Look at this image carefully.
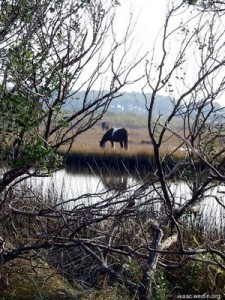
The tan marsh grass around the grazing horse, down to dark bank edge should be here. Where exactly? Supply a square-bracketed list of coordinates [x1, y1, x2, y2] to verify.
[61, 123, 193, 178]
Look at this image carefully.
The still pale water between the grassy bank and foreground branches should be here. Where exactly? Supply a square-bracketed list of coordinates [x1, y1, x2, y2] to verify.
[25, 170, 225, 237]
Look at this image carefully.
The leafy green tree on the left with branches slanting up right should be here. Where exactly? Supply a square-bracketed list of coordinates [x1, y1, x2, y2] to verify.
[0, 0, 142, 265]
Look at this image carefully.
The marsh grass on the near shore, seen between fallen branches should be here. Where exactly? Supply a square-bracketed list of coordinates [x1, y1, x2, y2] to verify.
[0, 190, 225, 300]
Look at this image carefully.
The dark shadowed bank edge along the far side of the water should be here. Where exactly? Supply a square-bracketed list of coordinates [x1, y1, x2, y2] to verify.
[65, 149, 207, 177]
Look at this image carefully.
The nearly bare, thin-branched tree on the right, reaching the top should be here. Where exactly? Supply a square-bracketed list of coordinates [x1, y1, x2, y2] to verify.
[140, 1, 225, 299]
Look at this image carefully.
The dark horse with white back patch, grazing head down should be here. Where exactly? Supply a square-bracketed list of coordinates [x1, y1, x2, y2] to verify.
[100, 128, 128, 149]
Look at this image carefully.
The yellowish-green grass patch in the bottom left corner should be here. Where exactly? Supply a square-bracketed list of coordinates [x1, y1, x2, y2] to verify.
[0, 254, 84, 300]
